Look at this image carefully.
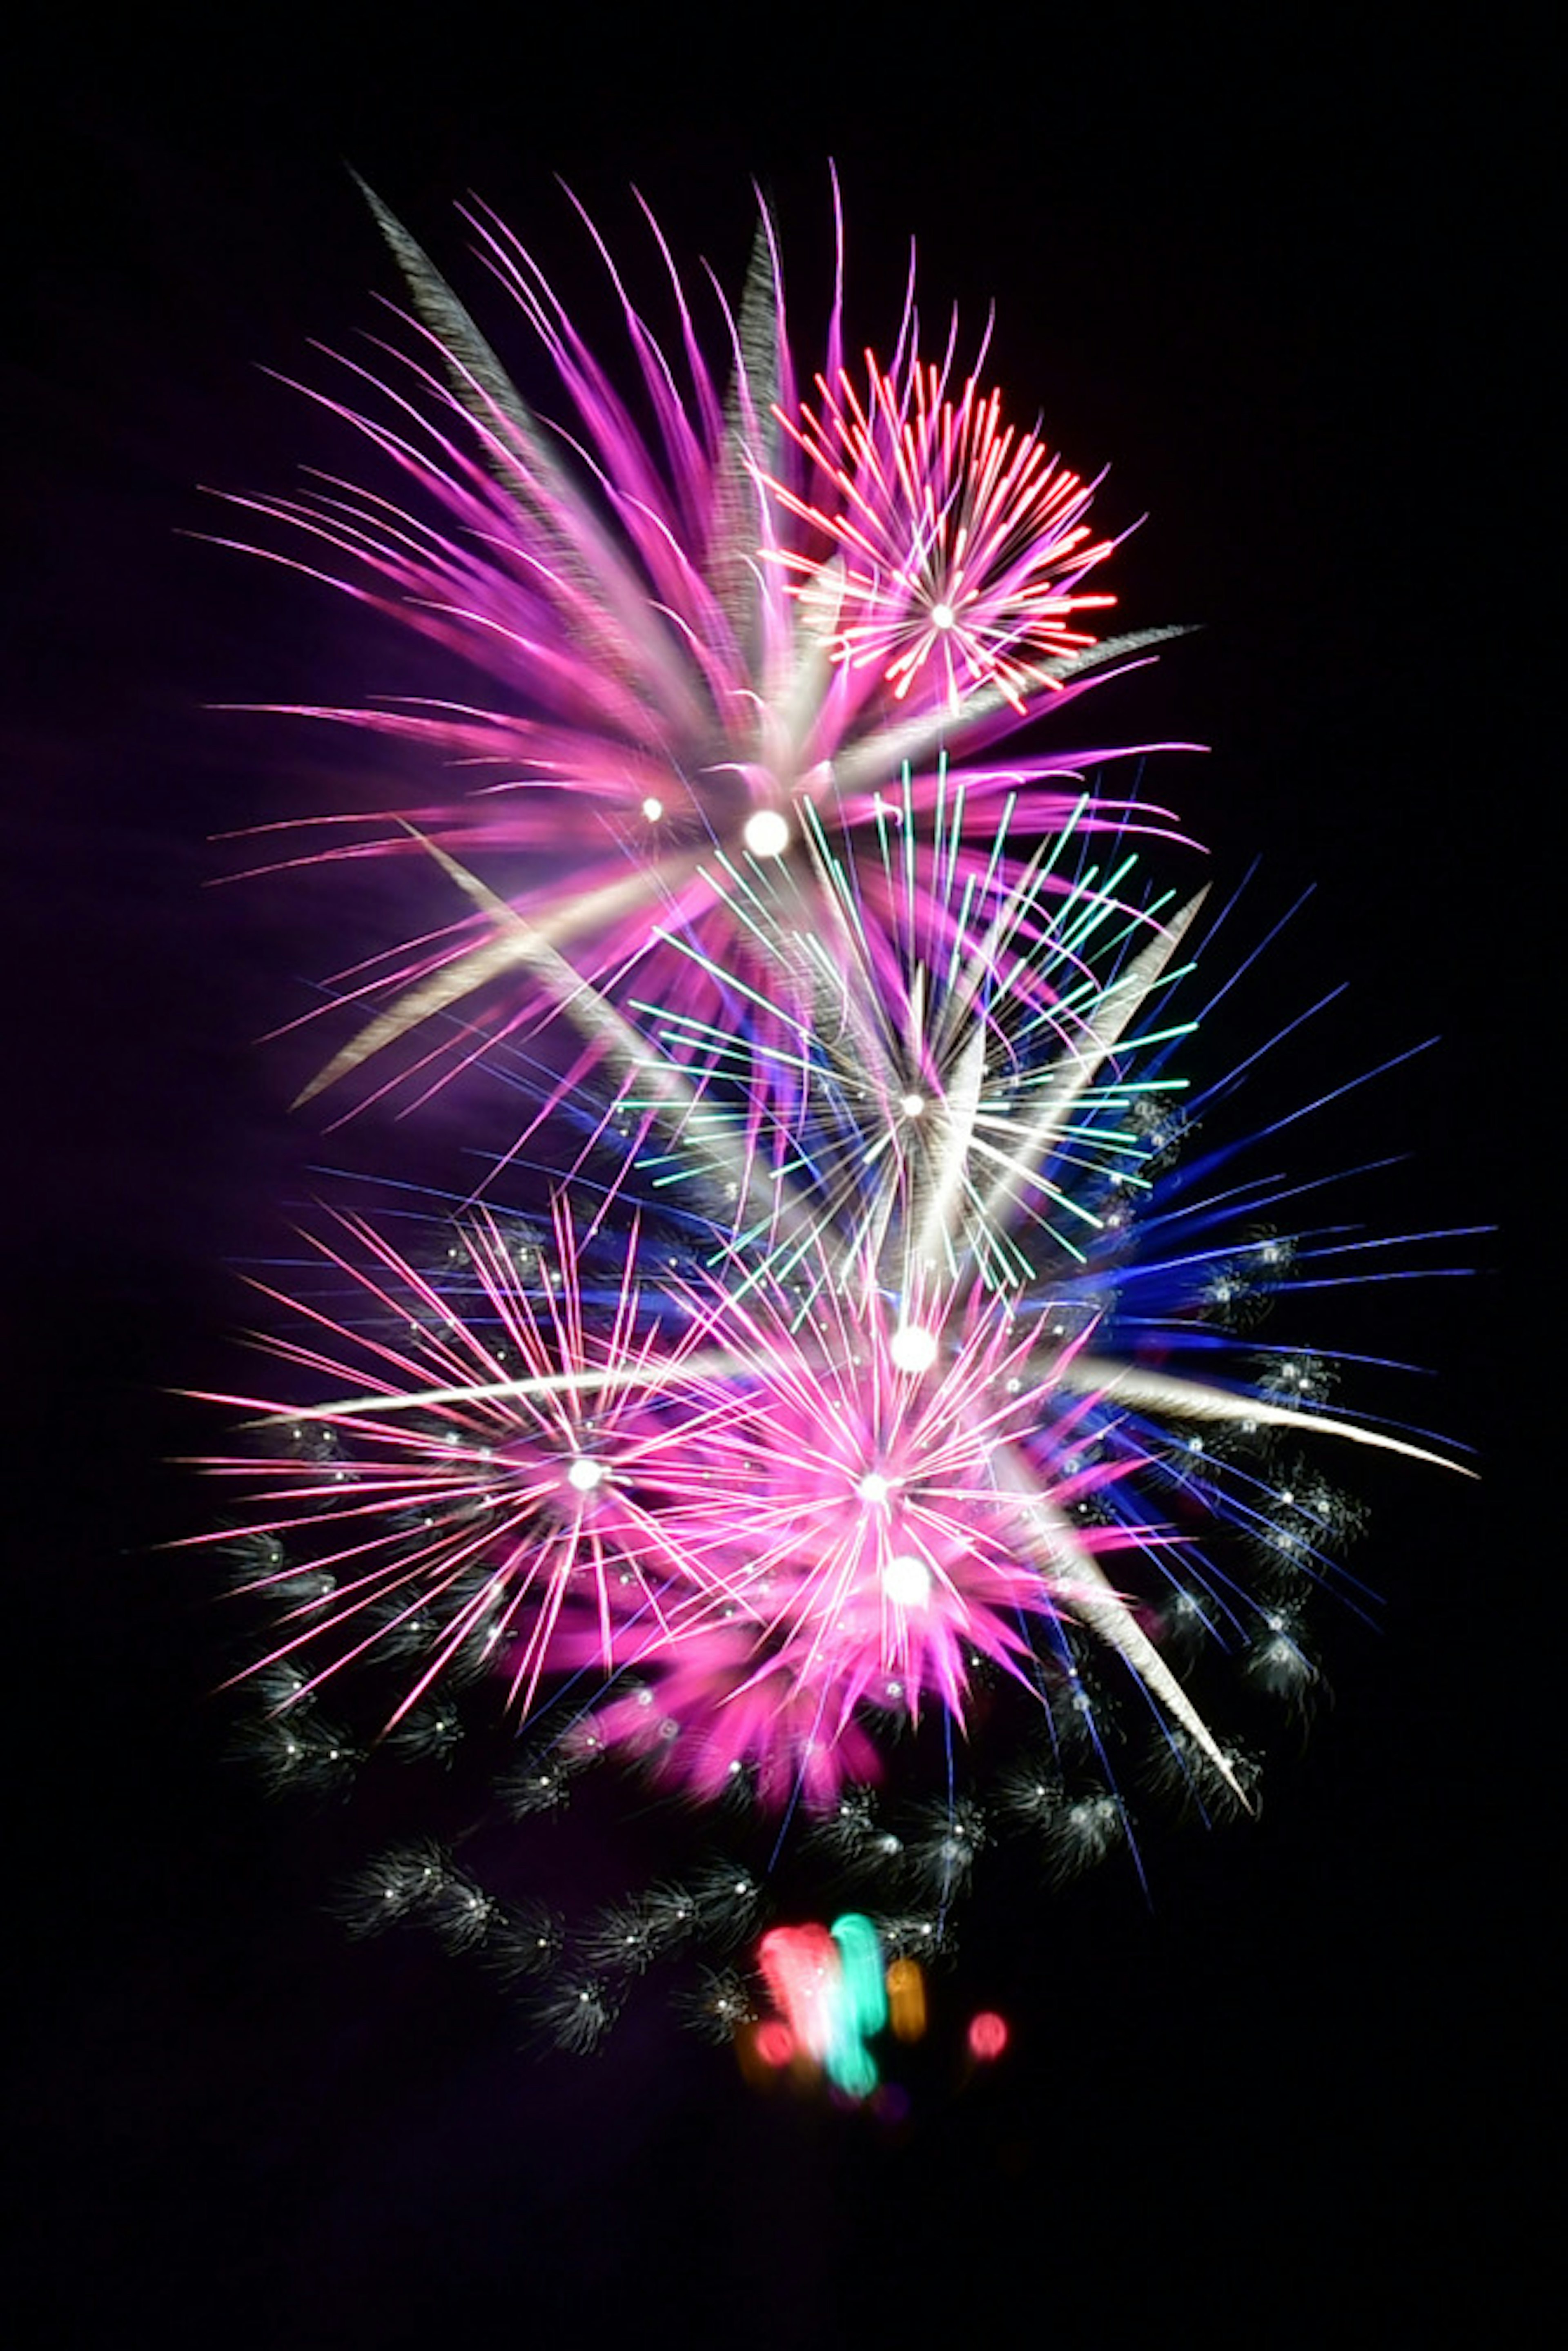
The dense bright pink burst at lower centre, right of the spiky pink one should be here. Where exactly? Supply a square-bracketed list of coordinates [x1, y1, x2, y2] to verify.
[555, 1265, 1133, 1810]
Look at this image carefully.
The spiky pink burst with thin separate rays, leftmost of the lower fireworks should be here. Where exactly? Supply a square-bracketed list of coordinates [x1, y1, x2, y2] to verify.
[190, 1201, 743, 1721]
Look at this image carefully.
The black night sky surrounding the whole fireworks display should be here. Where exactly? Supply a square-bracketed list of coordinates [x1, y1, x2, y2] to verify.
[5, 9, 1547, 2346]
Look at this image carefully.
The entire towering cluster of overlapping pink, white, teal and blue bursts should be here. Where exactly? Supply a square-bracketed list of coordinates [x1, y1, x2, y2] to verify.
[193, 183, 1453, 2048]
